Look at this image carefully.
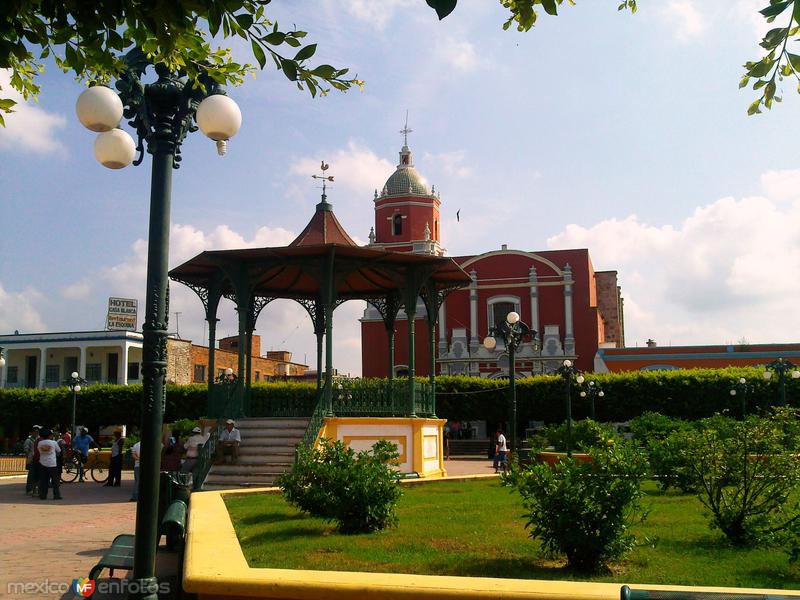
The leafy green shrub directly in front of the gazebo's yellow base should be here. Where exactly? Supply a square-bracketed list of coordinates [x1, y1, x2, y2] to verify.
[276, 439, 402, 533]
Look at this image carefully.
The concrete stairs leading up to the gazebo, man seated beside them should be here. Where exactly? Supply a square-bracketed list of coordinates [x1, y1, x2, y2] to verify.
[203, 418, 308, 490]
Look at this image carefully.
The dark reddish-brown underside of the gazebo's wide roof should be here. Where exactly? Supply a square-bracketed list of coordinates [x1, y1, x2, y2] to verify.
[169, 244, 470, 300]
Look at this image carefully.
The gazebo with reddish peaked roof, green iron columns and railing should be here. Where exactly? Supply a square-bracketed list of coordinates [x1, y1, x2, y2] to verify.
[169, 189, 470, 476]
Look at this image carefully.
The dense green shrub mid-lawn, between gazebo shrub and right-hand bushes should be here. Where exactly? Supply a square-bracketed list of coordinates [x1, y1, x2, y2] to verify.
[506, 444, 647, 573]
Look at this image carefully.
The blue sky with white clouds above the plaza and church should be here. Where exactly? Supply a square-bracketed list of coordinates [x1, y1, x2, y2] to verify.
[0, 0, 800, 375]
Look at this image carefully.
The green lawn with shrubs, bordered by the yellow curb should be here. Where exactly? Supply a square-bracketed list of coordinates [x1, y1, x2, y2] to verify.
[226, 480, 800, 589]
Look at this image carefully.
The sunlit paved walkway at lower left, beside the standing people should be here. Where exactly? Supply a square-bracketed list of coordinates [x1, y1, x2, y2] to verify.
[0, 472, 136, 600]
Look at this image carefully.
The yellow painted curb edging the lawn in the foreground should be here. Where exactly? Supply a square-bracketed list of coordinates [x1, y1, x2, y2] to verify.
[183, 488, 800, 600]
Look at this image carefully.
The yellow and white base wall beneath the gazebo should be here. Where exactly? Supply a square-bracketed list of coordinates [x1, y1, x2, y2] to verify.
[317, 417, 447, 478]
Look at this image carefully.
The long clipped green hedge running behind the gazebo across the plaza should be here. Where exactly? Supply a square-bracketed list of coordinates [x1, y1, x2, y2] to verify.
[0, 367, 800, 446]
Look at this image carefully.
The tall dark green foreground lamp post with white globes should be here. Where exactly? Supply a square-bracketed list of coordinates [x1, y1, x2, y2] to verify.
[76, 49, 242, 600]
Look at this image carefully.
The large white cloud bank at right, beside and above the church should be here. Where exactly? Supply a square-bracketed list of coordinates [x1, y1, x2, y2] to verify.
[547, 180, 800, 345]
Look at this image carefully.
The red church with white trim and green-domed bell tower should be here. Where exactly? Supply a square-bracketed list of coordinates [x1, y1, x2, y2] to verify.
[361, 138, 625, 377]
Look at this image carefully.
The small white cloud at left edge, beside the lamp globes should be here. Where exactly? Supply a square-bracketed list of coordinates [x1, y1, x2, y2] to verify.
[0, 69, 66, 155]
